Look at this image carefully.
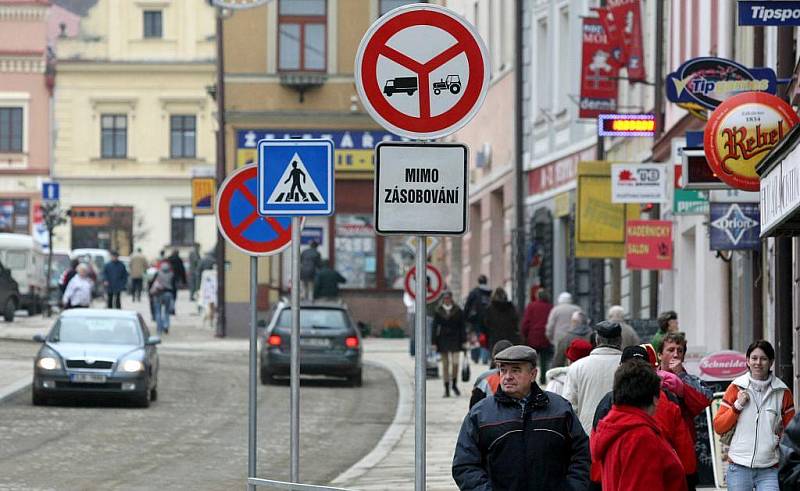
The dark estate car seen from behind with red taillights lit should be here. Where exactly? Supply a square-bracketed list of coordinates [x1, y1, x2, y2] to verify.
[260, 302, 362, 387]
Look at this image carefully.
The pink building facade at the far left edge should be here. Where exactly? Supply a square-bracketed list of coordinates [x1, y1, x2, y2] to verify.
[0, 0, 53, 245]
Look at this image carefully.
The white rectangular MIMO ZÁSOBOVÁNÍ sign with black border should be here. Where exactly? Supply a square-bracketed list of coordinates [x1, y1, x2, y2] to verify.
[375, 142, 469, 235]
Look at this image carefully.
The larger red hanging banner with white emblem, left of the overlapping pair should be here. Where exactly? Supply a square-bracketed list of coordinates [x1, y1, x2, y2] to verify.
[578, 17, 619, 118]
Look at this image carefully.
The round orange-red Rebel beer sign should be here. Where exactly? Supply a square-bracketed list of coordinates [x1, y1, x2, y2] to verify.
[703, 92, 800, 191]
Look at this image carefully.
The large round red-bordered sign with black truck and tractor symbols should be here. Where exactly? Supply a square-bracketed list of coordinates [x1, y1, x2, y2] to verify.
[355, 4, 490, 139]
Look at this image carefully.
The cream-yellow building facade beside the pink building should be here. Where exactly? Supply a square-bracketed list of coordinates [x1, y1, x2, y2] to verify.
[52, 0, 216, 258]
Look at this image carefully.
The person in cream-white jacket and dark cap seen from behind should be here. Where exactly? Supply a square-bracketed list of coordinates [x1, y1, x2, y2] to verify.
[564, 321, 622, 434]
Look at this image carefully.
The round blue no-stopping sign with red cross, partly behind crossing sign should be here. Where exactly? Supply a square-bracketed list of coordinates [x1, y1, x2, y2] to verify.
[216, 165, 292, 256]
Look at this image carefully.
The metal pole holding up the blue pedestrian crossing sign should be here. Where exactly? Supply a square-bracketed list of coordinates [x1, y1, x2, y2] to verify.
[289, 217, 300, 482]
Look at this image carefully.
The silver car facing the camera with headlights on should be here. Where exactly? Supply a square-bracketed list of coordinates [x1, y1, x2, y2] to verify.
[33, 309, 161, 407]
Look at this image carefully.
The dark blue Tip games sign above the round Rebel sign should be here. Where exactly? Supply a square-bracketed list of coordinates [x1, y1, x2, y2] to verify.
[666, 57, 778, 120]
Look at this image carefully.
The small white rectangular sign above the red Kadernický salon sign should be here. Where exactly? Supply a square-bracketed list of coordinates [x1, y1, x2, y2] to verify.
[611, 164, 669, 203]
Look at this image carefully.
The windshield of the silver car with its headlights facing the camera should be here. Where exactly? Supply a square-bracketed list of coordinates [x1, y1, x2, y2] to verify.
[50, 317, 141, 345]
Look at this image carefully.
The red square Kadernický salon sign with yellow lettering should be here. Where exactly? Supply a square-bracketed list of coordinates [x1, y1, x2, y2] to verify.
[625, 220, 672, 269]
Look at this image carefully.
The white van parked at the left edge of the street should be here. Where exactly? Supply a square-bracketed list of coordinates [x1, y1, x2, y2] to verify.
[0, 233, 47, 315]
